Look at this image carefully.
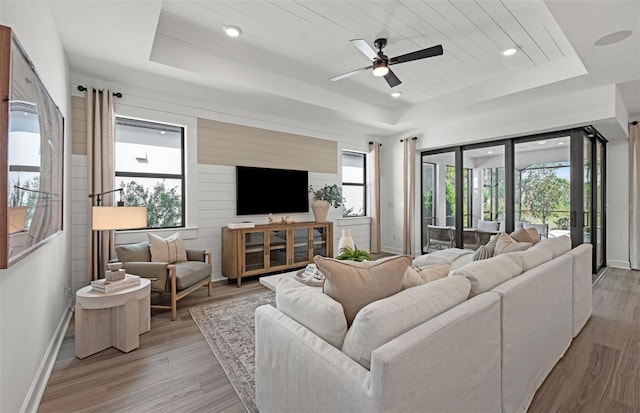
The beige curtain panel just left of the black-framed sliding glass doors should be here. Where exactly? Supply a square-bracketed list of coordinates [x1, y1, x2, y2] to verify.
[402, 138, 417, 255]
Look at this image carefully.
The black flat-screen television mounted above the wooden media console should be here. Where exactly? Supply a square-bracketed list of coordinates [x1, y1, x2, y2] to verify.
[236, 166, 309, 215]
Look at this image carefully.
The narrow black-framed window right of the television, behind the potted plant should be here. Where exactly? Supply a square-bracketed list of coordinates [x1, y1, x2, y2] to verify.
[342, 151, 367, 217]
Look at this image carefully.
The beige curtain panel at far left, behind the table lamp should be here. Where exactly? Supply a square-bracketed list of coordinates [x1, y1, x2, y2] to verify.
[85, 87, 115, 279]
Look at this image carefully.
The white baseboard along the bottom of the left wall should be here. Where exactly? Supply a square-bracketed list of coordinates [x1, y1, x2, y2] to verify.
[20, 308, 73, 413]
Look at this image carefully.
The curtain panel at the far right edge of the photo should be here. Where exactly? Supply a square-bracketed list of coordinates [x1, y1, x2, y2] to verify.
[629, 122, 640, 270]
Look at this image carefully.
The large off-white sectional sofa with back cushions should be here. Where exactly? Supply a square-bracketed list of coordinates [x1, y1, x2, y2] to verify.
[255, 237, 591, 413]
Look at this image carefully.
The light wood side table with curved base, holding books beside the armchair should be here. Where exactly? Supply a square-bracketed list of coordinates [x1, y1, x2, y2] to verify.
[75, 278, 151, 359]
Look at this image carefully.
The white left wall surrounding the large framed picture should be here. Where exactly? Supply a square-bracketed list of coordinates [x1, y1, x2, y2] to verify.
[0, 0, 72, 412]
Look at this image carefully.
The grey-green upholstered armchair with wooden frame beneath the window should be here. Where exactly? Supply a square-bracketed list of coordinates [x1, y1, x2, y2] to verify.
[116, 241, 211, 320]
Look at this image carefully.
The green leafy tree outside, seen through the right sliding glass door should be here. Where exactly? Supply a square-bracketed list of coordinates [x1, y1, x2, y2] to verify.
[520, 168, 570, 224]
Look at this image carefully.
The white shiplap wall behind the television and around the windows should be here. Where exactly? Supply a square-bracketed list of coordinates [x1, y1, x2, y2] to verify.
[72, 75, 370, 282]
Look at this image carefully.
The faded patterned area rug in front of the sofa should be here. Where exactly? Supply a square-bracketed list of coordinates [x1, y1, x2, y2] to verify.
[190, 290, 275, 413]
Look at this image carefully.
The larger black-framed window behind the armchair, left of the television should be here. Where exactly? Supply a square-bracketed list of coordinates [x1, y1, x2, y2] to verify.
[115, 117, 185, 228]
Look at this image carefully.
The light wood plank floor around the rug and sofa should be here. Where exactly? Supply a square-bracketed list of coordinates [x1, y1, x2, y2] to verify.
[39, 269, 640, 413]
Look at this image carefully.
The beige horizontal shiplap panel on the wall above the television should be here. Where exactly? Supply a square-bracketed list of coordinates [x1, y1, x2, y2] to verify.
[198, 118, 338, 174]
